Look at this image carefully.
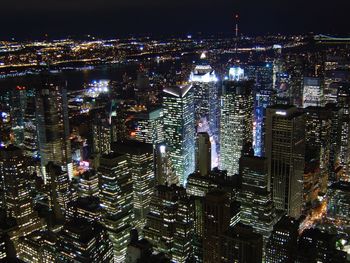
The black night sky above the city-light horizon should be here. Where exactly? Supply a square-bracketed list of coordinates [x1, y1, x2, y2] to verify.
[0, 0, 350, 39]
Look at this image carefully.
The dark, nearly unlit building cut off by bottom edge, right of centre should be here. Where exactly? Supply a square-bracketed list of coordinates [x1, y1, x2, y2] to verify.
[220, 224, 263, 263]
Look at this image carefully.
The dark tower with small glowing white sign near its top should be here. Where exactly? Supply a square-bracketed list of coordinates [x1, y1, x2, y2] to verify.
[266, 105, 305, 218]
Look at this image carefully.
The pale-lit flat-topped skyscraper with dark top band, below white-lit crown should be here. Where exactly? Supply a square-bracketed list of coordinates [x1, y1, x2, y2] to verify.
[220, 81, 253, 176]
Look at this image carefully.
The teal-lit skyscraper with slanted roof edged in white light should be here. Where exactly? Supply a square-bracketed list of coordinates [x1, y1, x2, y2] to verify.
[163, 85, 195, 185]
